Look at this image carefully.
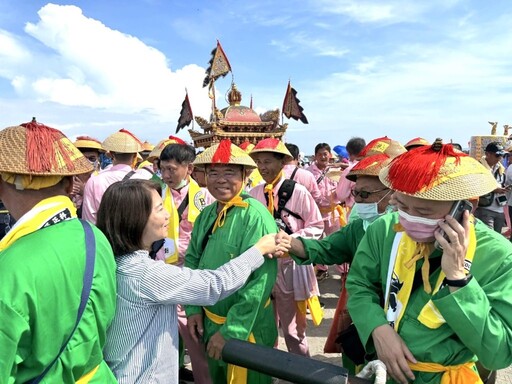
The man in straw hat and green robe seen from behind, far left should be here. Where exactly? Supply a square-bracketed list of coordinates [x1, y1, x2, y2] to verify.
[0, 120, 117, 384]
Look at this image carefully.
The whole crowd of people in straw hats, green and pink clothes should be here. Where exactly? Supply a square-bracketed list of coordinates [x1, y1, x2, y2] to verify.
[0, 121, 512, 384]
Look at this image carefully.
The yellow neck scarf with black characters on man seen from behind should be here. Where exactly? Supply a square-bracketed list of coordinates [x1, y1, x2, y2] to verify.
[0, 196, 76, 251]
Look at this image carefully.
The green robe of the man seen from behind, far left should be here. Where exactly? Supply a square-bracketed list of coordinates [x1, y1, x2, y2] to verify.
[0, 220, 117, 384]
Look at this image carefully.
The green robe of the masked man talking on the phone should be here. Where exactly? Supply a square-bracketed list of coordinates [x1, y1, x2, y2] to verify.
[347, 213, 512, 383]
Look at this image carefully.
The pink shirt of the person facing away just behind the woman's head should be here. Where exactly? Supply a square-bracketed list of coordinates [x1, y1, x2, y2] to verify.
[82, 164, 153, 224]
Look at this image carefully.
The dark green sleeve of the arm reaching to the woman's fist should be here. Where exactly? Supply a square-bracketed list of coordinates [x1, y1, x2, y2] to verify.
[290, 219, 365, 265]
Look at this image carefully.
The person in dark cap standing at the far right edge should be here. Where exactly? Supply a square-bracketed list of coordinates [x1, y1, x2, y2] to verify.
[475, 143, 507, 233]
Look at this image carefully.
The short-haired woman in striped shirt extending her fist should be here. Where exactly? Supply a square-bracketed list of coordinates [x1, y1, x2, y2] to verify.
[97, 180, 284, 383]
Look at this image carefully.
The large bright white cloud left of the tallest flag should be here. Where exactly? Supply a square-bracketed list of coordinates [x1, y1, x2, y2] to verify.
[16, 4, 208, 117]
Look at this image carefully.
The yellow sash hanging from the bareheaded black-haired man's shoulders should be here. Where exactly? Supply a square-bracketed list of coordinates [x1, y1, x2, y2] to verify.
[164, 177, 206, 264]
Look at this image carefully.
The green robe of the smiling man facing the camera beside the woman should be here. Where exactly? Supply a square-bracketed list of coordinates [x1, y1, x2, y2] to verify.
[185, 197, 277, 384]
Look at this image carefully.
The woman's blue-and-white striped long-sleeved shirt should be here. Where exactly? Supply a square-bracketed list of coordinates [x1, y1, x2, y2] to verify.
[104, 247, 264, 384]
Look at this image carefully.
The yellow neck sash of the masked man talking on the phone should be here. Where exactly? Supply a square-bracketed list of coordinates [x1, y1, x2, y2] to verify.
[385, 216, 476, 329]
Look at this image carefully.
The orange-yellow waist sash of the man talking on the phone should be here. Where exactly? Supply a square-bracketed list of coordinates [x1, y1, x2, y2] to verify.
[408, 362, 482, 384]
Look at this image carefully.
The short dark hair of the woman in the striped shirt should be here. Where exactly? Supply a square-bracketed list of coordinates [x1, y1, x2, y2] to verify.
[96, 179, 162, 257]
